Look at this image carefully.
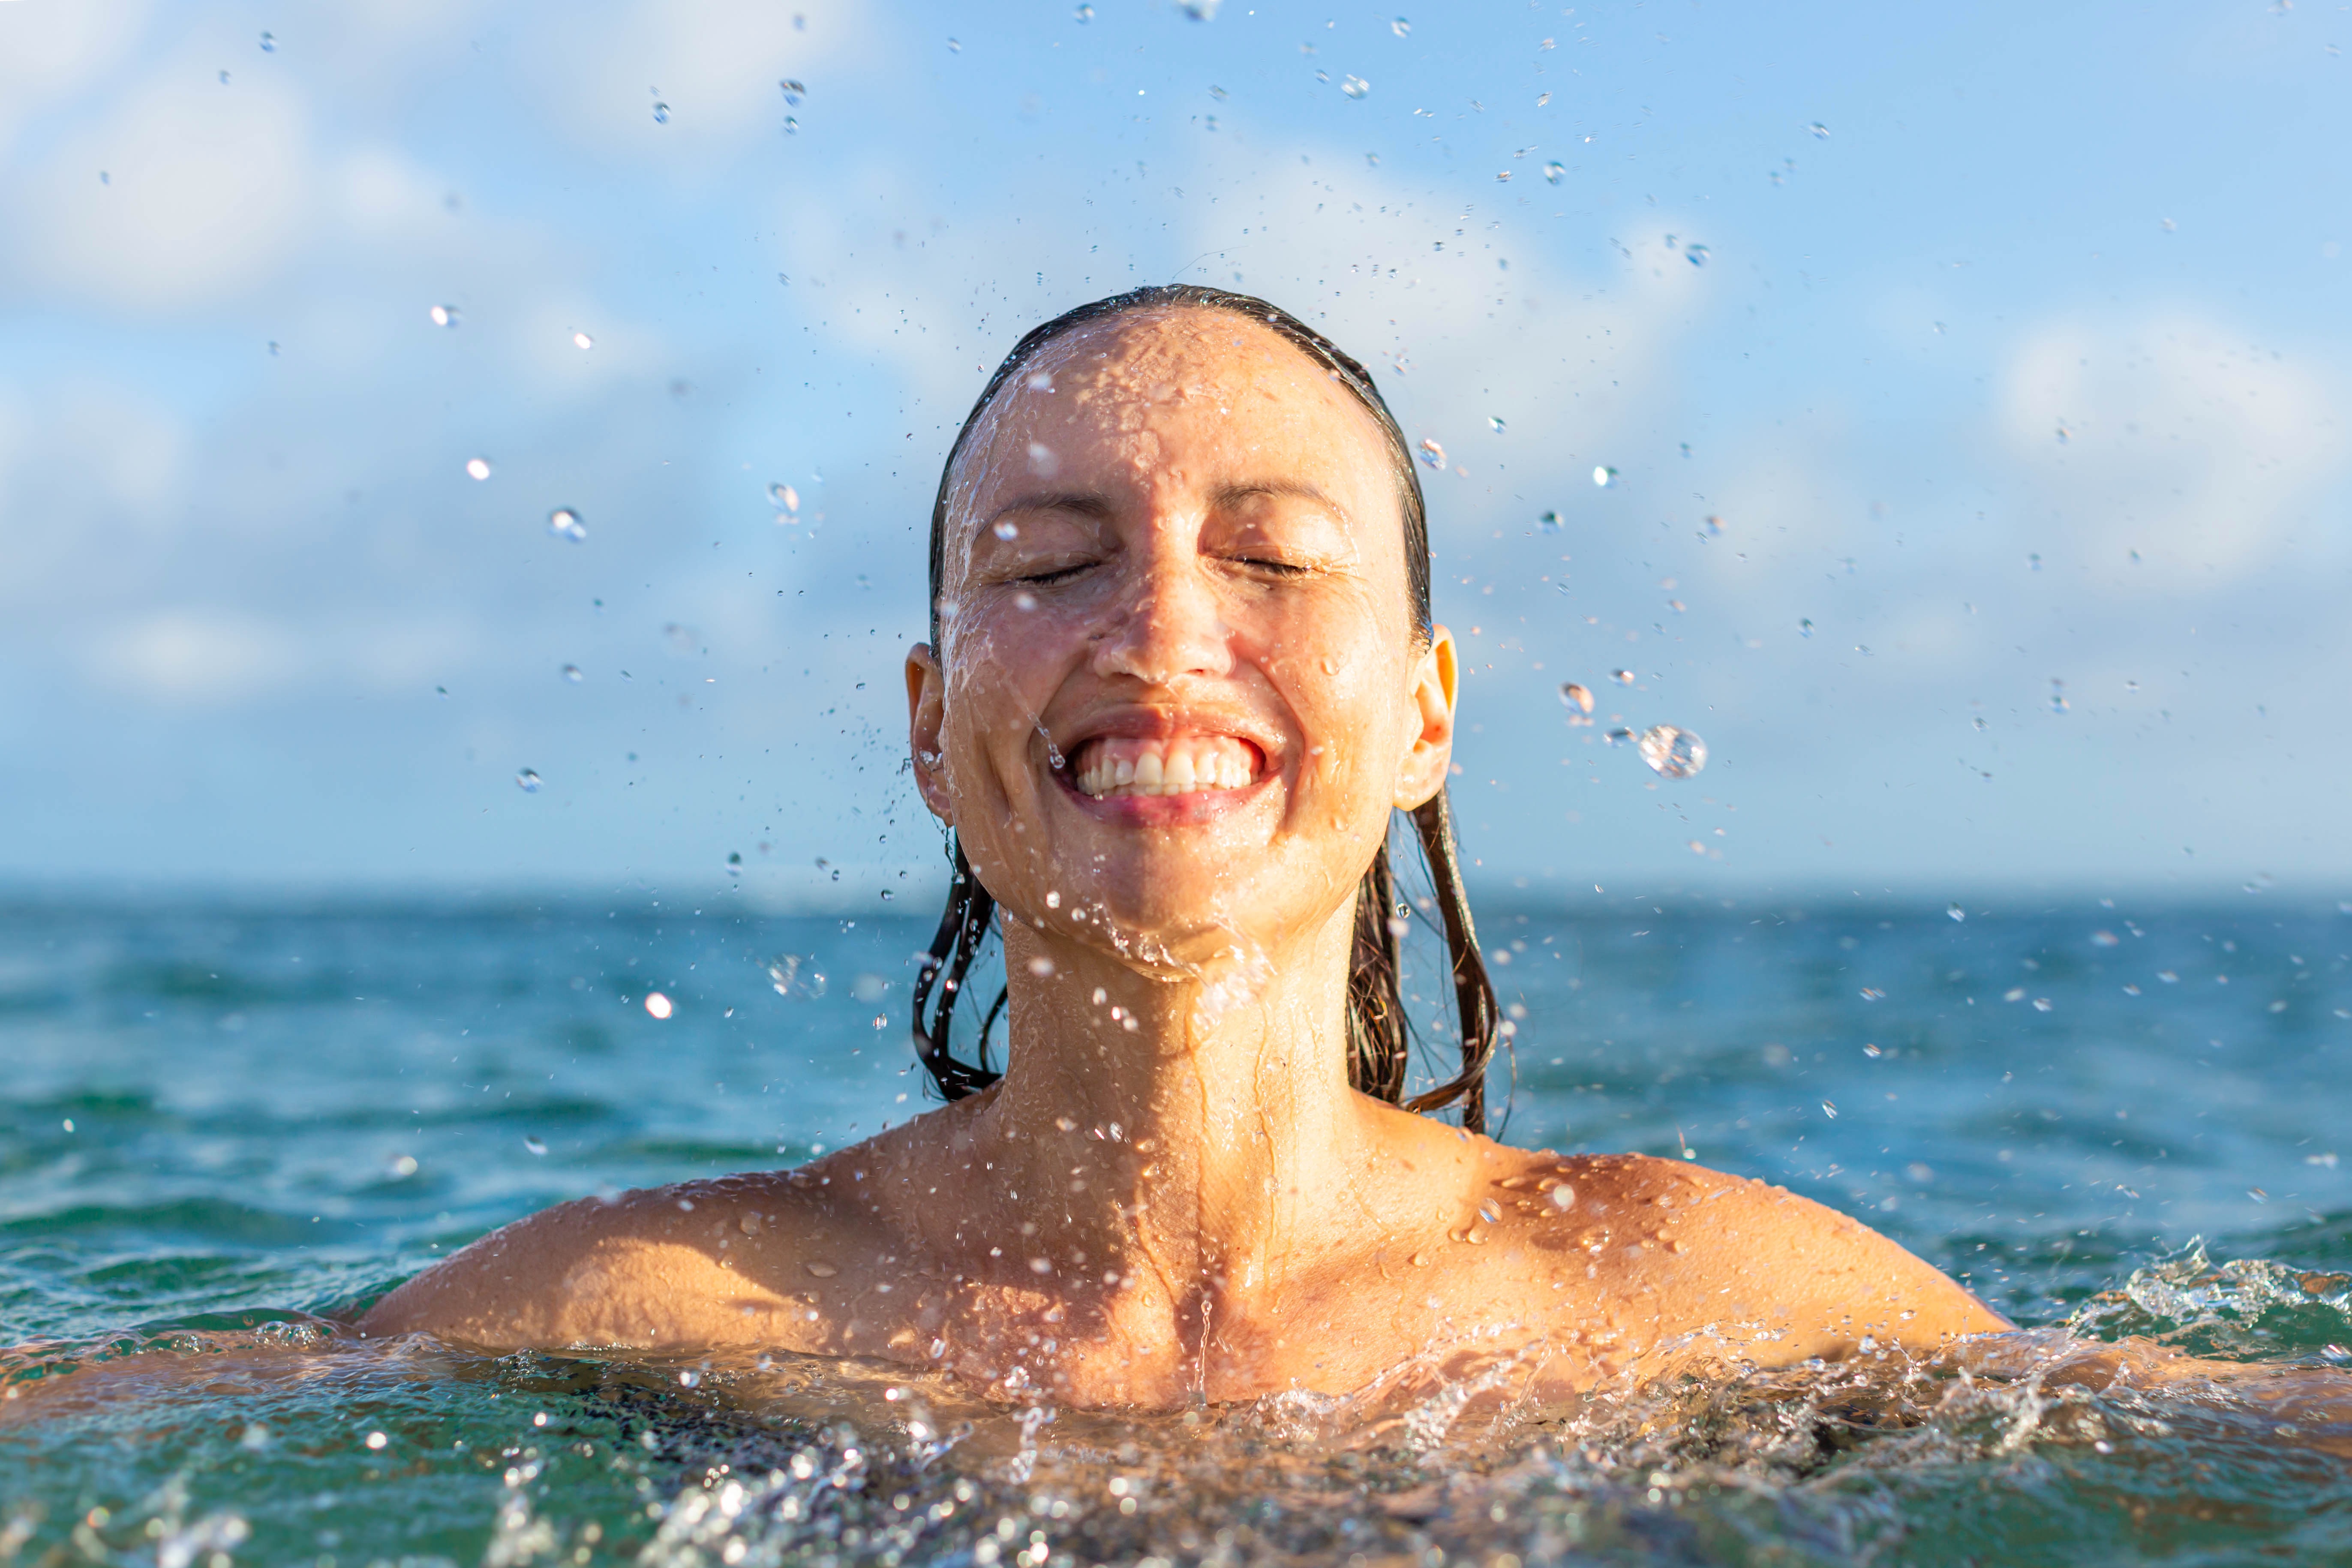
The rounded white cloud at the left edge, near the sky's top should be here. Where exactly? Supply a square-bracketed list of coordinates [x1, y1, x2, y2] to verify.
[0, 57, 308, 310]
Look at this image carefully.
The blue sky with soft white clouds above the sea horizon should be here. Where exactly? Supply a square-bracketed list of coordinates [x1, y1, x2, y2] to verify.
[0, 0, 2352, 907]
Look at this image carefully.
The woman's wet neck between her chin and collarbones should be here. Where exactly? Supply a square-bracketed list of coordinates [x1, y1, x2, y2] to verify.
[974, 893, 1367, 1310]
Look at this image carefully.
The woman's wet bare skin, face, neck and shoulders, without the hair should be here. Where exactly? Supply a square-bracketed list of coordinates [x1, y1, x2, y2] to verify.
[362, 308, 2006, 1408]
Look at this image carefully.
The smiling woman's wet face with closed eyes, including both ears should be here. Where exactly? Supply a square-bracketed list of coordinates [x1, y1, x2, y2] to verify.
[908, 308, 1454, 969]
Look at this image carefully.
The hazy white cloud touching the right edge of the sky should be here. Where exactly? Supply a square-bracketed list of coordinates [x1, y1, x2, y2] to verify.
[1999, 315, 2345, 586]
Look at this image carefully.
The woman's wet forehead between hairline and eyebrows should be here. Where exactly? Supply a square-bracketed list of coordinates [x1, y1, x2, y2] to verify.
[960, 306, 1388, 489]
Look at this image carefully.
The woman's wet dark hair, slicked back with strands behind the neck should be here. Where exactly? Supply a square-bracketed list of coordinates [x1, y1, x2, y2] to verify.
[915, 285, 1501, 1133]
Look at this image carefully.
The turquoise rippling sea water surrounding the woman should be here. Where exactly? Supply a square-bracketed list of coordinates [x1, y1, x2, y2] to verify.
[0, 896, 2352, 1568]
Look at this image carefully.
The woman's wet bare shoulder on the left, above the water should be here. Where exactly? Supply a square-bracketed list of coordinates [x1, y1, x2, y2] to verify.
[360, 1168, 884, 1349]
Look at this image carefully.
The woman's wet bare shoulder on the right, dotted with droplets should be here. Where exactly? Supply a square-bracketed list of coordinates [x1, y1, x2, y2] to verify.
[1512, 1154, 2009, 1364]
